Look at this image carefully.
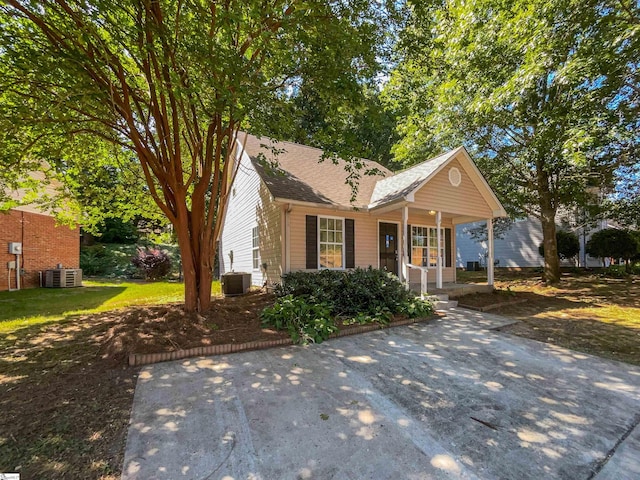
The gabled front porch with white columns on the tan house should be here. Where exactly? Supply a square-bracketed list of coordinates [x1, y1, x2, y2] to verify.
[369, 147, 506, 297]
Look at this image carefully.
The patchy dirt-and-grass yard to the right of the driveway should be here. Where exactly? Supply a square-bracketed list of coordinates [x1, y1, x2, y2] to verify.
[459, 272, 640, 365]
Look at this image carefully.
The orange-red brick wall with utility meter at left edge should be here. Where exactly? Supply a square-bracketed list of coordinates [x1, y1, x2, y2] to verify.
[0, 210, 80, 290]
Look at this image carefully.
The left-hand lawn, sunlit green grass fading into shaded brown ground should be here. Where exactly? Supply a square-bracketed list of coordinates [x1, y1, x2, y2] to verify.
[0, 281, 220, 480]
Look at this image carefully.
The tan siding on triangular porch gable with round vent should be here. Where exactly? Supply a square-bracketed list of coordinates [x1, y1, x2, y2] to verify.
[415, 159, 493, 218]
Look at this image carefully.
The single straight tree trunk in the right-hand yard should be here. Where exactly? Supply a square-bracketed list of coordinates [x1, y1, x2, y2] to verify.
[538, 165, 560, 285]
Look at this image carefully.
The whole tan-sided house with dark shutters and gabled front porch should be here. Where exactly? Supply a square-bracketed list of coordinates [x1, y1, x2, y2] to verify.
[219, 134, 505, 286]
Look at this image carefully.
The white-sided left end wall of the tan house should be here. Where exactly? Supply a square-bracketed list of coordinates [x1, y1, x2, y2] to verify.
[219, 150, 282, 286]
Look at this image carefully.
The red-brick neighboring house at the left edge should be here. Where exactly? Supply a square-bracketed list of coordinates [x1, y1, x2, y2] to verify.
[0, 172, 80, 291]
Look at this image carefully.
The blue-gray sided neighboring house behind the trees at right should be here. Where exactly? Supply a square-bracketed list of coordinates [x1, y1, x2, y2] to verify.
[456, 216, 609, 268]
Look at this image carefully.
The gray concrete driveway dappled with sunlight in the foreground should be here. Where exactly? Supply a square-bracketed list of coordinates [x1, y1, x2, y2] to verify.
[123, 310, 640, 480]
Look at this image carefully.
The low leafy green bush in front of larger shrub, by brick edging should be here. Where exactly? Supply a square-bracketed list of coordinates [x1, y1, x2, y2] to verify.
[260, 295, 338, 345]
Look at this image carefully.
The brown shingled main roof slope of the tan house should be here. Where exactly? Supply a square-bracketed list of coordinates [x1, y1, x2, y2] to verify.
[238, 132, 392, 208]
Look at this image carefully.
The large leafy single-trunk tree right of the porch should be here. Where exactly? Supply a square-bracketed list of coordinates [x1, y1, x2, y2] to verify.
[385, 0, 640, 283]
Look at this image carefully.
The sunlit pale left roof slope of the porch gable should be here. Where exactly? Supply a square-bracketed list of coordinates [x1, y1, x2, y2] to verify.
[369, 147, 462, 208]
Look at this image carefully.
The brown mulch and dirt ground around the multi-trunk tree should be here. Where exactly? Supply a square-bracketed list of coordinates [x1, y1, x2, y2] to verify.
[0, 292, 436, 480]
